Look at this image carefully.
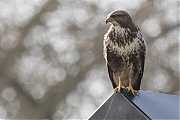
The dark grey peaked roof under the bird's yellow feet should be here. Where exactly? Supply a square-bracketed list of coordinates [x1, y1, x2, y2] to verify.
[89, 90, 180, 120]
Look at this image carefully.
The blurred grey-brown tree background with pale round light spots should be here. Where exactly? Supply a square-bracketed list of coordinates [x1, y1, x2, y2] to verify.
[0, 0, 180, 119]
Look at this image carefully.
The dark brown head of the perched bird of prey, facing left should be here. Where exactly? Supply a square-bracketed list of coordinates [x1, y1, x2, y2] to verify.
[106, 10, 132, 26]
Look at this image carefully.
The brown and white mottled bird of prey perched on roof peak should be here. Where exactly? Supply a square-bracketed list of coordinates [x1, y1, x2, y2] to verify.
[103, 10, 146, 95]
